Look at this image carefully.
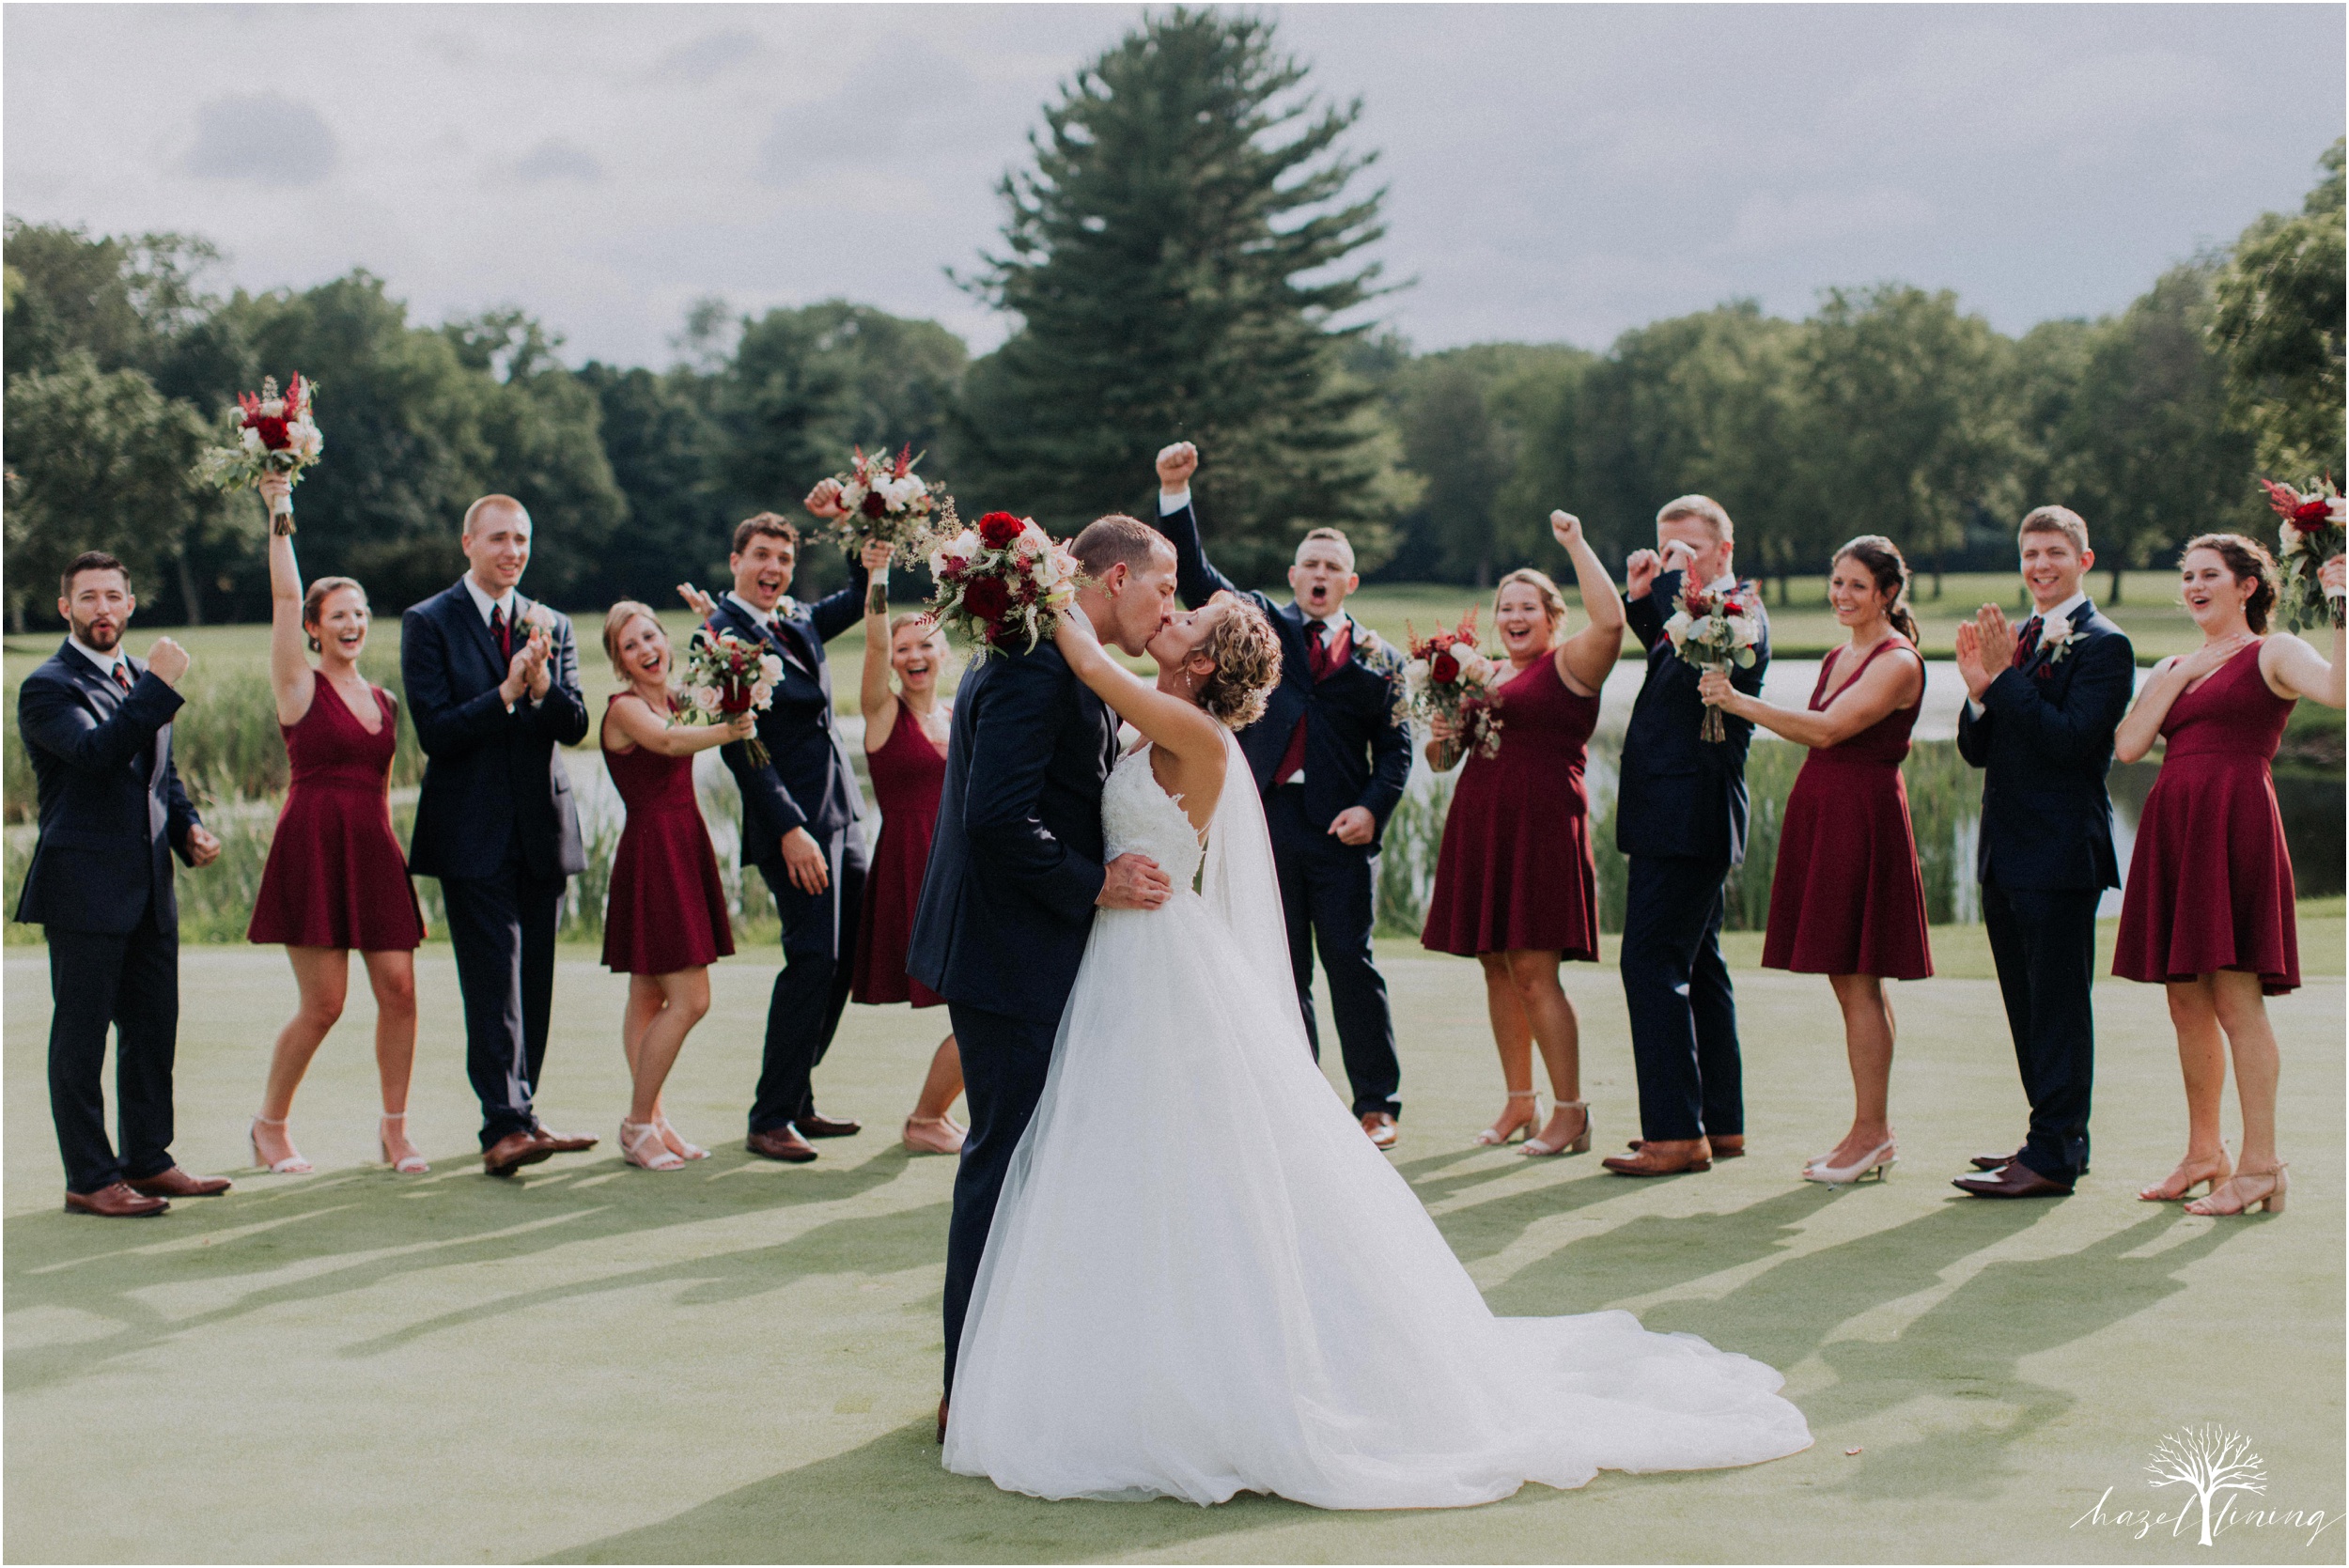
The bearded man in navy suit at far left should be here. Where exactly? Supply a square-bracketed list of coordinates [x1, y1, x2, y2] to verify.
[17, 550, 228, 1219]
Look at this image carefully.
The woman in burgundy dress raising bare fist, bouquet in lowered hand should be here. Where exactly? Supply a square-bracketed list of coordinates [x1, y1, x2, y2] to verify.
[1419, 512, 1624, 1155]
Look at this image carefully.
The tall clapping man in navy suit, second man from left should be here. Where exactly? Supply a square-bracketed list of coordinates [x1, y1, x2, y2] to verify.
[399, 495, 595, 1176]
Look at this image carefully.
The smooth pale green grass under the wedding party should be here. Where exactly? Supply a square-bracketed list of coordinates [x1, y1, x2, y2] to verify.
[0, 939, 2344, 1563]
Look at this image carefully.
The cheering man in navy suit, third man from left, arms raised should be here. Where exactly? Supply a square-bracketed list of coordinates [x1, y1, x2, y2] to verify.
[689, 509, 867, 1164]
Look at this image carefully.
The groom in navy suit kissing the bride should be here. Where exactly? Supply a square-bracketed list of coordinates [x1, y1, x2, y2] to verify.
[905, 517, 1174, 1441]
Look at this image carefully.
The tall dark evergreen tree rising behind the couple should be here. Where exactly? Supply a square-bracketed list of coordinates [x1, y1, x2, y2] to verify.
[958, 7, 1398, 575]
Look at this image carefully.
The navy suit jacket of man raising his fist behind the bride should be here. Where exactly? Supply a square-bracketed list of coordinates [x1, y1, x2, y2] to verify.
[1159, 507, 1412, 854]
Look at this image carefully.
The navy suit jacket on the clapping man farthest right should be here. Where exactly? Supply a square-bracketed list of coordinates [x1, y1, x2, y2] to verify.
[1957, 603, 2138, 890]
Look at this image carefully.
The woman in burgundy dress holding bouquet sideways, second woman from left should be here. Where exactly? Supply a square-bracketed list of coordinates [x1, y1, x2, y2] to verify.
[597, 598, 756, 1172]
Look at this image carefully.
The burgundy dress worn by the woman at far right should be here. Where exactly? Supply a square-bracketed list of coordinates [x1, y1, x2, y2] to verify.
[2112, 644, 2300, 995]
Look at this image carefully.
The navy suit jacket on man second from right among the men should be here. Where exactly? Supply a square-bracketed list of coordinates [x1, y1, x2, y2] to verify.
[1616, 570, 1769, 866]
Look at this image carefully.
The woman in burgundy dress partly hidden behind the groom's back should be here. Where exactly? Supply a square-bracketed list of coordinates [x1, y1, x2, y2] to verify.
[848, 551, 963, 1155]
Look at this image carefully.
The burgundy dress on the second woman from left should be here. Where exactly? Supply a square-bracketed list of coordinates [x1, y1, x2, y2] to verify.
[599, 697, 733, 974]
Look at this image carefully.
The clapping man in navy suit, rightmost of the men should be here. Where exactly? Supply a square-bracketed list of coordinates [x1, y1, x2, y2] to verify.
[1957, 507, 2138, 1197]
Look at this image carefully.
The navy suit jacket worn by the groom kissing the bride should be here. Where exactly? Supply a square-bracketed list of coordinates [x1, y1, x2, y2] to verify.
[905, 639, 1118, 1023]
